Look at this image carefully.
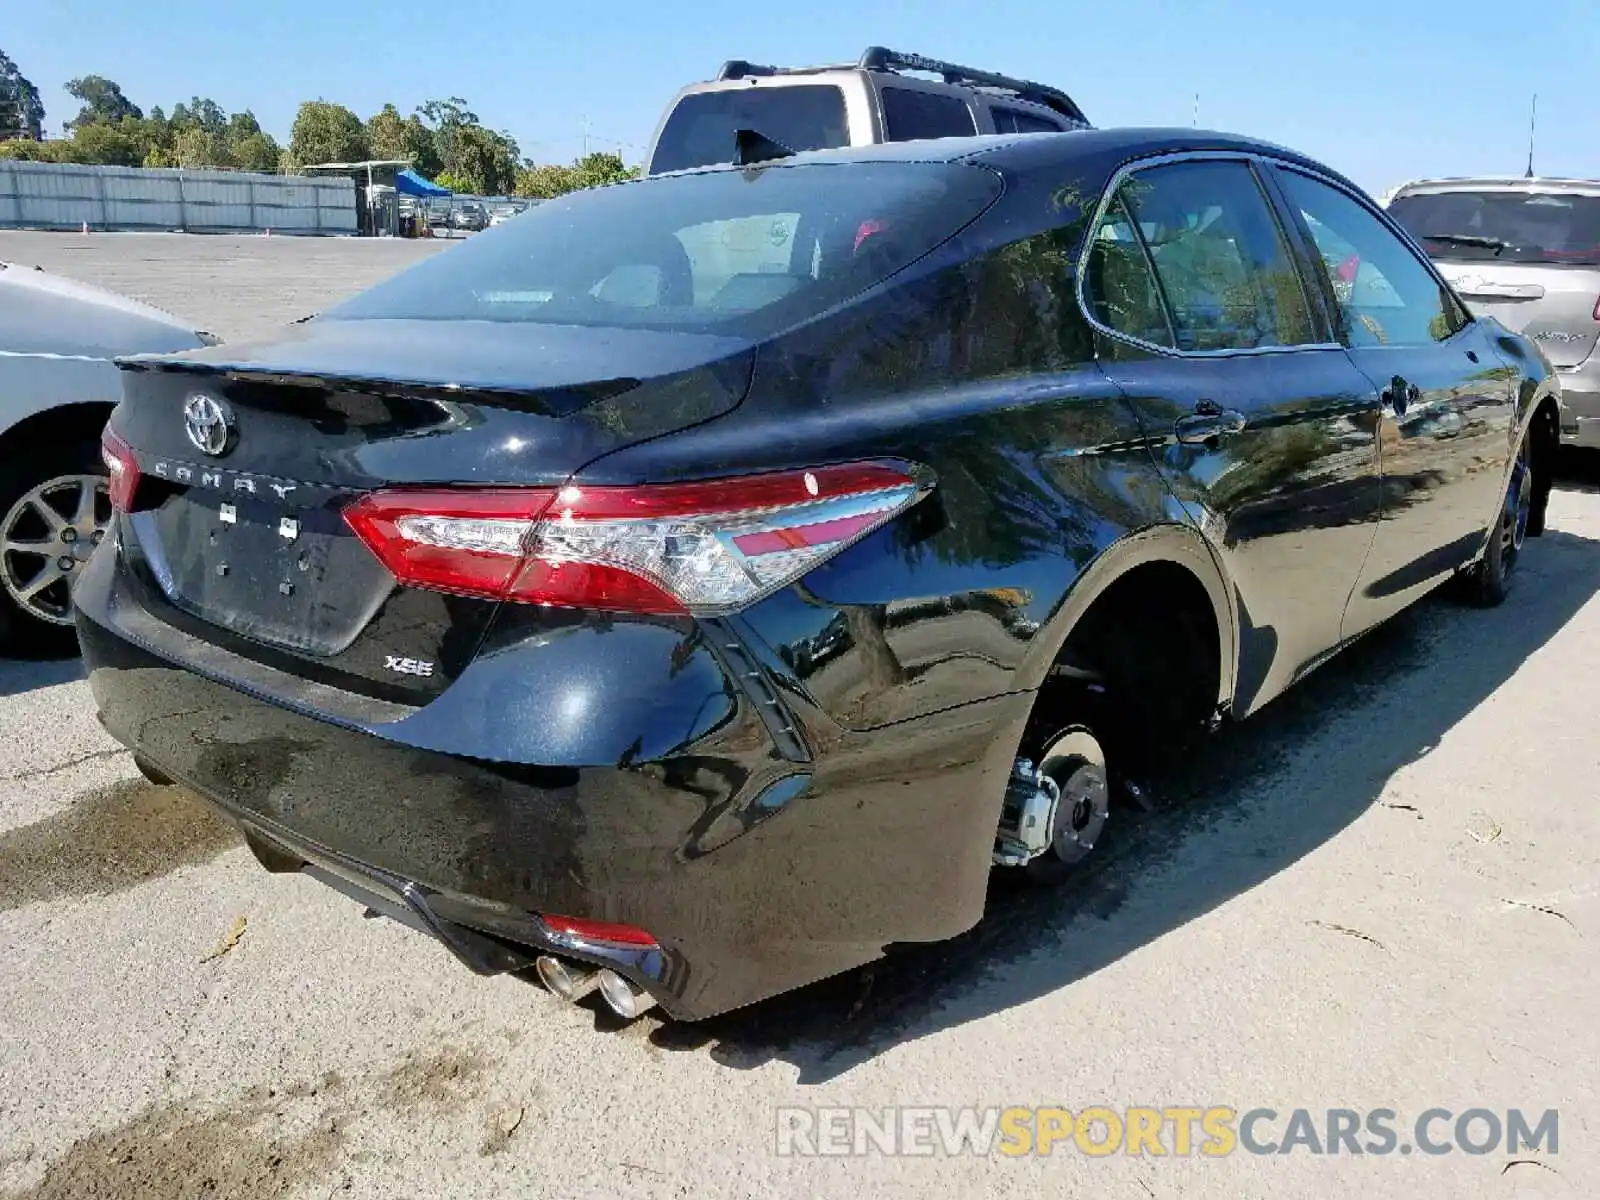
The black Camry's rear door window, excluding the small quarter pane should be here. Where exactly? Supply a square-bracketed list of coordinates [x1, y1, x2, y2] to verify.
[1122, 162, 1318, 350]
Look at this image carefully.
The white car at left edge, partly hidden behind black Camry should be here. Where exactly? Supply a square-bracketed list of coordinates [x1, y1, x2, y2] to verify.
[0, 262, 218, 654]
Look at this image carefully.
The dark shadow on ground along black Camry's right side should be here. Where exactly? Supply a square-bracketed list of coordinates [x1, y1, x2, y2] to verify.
[651, 521, 1600, 1083]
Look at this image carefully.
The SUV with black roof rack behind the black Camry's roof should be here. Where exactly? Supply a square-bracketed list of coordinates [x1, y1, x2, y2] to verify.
[650, 46, 1091, 174]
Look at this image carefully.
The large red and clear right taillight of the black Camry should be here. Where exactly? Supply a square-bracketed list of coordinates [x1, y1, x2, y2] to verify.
[346, 462, 926, 614]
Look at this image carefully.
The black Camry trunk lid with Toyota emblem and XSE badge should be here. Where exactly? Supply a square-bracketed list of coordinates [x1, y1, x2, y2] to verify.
[112, 320, 750, 702]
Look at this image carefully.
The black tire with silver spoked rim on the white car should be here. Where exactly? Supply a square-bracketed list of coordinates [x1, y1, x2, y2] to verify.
[0, 437, 110, 658]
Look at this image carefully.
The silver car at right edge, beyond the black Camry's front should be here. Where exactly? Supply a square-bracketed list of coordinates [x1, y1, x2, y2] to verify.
[1389, 178, 1600, 446]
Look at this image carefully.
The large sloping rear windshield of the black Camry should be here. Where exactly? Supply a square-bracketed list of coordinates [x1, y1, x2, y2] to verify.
[325, 163, 1000, 338]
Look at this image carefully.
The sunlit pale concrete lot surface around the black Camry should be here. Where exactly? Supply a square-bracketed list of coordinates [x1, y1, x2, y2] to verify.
[0, 235, 1600, 1200]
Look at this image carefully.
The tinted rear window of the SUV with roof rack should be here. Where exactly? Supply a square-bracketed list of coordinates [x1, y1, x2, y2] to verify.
[650, 83, 850, 174]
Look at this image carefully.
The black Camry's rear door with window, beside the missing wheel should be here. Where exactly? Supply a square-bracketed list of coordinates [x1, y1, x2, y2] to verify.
[1085, 155, 1379, 715]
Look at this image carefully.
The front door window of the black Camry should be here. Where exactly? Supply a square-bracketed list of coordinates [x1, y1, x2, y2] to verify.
[1278, 170, 1466, 346]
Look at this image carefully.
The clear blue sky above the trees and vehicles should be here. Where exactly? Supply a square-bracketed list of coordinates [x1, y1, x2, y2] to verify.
[0, 0, 1600, 192]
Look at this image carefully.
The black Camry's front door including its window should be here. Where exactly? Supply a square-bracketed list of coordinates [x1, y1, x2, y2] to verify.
[1274, 165, 1515, 637]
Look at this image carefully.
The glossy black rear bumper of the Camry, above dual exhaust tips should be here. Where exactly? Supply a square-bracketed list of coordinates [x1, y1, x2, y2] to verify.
[77, 542, 1030, 1019]
